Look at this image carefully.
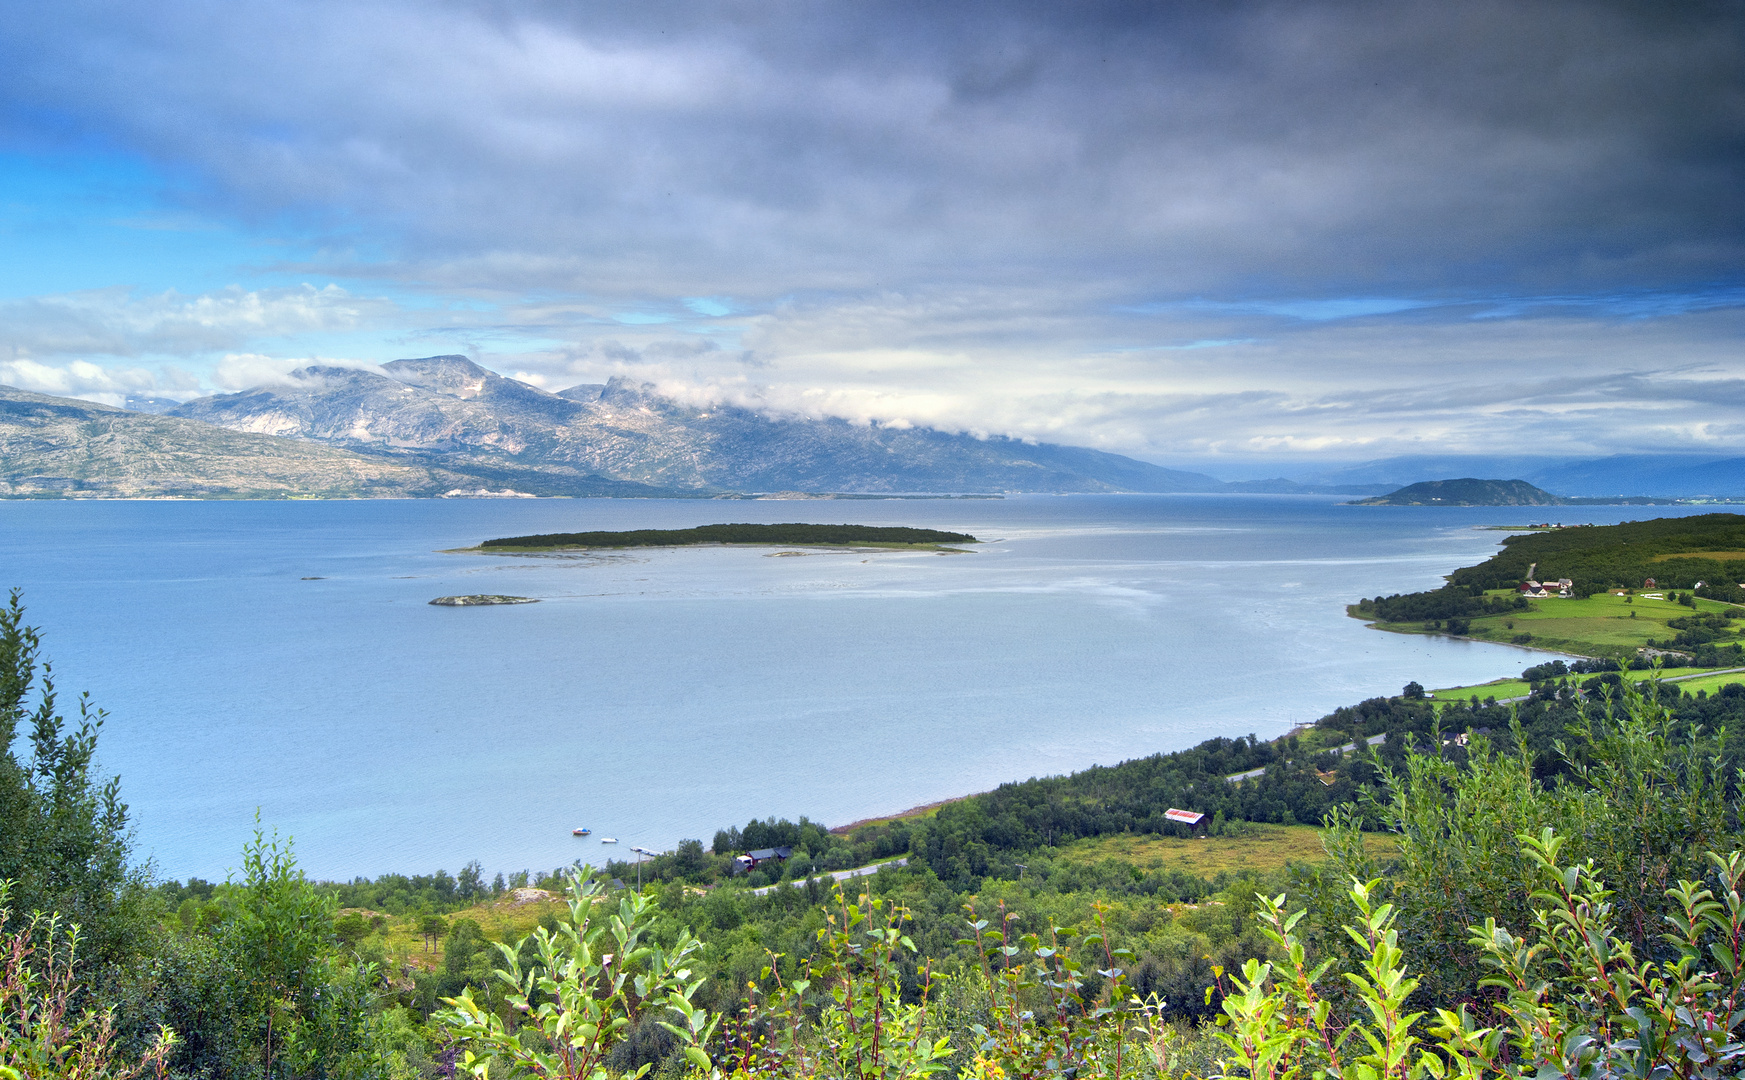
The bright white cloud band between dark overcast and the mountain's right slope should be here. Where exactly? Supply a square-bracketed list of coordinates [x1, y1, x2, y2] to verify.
[464, 293, 1745, 461]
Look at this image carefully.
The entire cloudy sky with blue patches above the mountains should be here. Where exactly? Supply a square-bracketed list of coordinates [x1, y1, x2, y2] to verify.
[0, 0, 1745, 475]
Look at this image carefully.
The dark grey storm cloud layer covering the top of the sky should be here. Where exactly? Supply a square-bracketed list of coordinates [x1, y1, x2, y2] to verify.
[0, 0, 1745, 300]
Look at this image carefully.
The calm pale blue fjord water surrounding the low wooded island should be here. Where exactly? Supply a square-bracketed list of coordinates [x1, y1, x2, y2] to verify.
[0, 496, 1717, 878]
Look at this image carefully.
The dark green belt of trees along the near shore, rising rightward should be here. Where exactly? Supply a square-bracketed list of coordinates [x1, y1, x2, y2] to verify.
[607, 649, 1745, 892]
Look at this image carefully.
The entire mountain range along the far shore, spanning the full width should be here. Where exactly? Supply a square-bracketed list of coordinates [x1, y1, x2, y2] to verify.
[0, 356, 1745, 497]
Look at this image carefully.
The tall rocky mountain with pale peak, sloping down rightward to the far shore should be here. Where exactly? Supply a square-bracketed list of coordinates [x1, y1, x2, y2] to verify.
[171, 356, 1227, 492]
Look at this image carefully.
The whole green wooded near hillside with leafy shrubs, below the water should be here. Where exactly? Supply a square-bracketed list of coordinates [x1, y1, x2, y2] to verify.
[10, 582, 1745, 1080]
